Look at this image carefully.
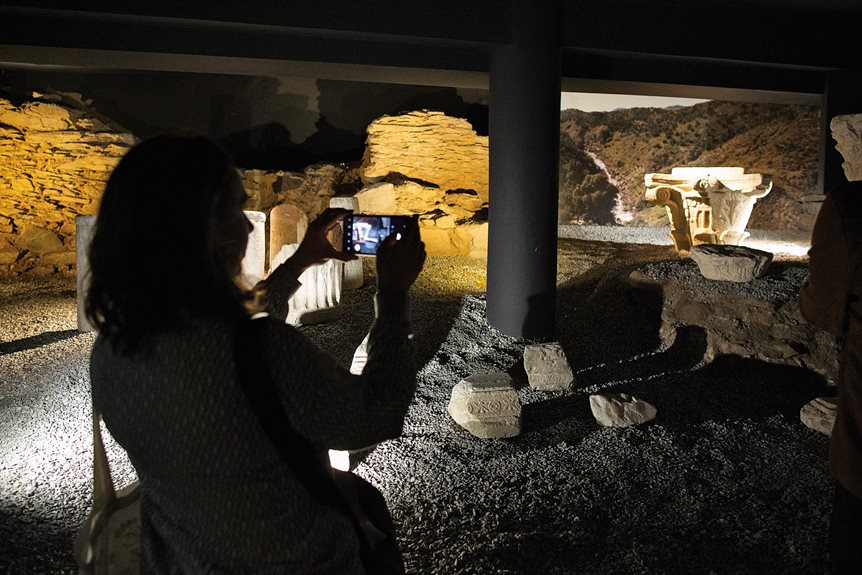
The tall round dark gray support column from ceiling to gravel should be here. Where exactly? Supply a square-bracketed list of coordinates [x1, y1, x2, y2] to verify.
[487, 0, 560, 339]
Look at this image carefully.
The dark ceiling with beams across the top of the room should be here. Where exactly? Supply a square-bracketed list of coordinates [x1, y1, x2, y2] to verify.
[0, 0, 862, 98]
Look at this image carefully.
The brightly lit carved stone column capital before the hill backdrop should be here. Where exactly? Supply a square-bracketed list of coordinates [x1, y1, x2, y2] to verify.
[644, 167, 772, 254]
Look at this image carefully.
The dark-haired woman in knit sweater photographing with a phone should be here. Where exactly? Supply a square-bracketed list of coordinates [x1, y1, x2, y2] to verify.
[87, 137, 425, 574]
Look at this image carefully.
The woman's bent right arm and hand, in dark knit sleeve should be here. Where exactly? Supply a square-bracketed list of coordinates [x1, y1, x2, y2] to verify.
[266, 219, 425, 449]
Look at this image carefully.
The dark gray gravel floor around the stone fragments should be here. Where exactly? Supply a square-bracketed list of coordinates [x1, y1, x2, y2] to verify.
[0, 235, 831, 575]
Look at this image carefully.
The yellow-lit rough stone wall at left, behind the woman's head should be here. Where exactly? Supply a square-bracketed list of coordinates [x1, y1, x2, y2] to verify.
[0, 94, 135, 275]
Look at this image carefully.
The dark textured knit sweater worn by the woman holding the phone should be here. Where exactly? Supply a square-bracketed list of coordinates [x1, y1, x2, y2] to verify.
[90, 276, 416, 574]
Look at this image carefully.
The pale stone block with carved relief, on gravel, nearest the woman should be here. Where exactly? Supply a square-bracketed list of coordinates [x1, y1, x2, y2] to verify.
[448, 372, 521, 438]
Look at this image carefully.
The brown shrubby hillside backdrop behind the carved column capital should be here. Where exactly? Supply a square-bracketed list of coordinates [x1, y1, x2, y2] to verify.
[560, 101, 820, 229]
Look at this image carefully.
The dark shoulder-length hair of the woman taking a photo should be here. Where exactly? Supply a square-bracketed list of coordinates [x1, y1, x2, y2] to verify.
[85, 136, 248, 351]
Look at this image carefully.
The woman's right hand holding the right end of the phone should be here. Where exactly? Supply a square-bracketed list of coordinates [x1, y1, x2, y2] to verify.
[377, 216, 425, 292]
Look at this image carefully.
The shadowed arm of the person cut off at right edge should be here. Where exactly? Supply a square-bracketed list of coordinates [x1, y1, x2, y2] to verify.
[799, 195, 850, 337]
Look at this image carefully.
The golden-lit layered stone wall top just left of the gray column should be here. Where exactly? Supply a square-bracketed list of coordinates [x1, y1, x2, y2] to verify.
[361, 110, 488, 201]
